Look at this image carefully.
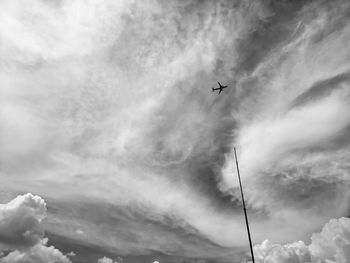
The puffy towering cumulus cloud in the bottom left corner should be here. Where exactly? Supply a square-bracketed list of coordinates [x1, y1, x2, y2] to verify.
[0, 193, 71, 263]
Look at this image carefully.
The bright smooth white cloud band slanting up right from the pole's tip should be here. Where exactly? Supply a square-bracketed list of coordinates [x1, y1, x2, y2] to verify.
[224, 85, 350, 185]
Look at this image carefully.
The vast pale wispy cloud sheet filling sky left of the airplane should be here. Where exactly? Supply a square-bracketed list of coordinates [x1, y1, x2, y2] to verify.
[0, 0, 266, 254]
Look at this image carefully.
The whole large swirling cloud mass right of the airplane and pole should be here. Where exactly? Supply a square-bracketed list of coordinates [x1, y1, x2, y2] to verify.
[219, 1, 350, 246]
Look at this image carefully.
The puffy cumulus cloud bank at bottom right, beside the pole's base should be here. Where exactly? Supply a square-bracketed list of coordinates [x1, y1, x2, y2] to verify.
[254, 217, 350, 263]
